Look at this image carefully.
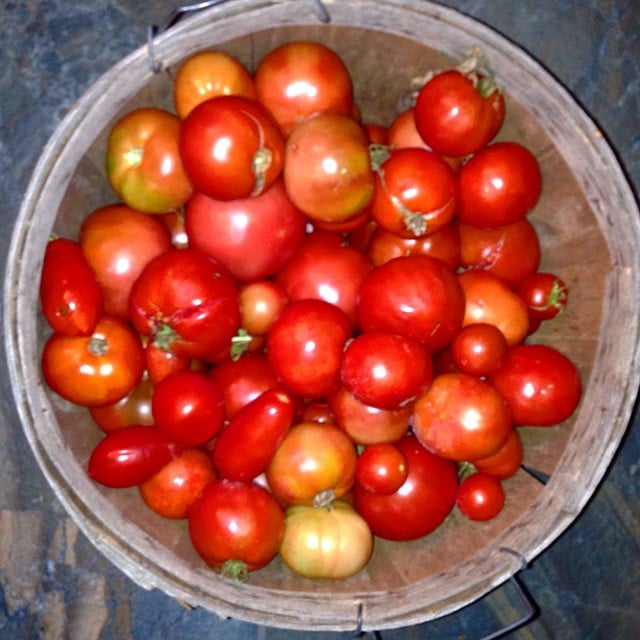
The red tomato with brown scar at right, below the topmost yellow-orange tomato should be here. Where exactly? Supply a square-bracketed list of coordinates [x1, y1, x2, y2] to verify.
[180, 96, 284, 200]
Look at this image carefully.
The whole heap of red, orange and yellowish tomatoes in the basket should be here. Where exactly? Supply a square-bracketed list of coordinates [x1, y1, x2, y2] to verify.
[40, 41, 581, 578]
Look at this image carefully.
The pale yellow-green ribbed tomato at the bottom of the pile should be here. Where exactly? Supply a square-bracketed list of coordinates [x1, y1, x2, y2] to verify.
[280, 500, 373, 579]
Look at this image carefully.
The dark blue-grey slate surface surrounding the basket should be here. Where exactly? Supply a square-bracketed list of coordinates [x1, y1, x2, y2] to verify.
[0, 0, 640, 640]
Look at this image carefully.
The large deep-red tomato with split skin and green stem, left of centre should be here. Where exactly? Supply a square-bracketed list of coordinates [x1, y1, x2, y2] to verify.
[129, 249, 240, 359]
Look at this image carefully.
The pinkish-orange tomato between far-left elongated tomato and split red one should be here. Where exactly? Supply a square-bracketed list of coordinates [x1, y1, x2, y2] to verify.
[80, 204, 172, 318]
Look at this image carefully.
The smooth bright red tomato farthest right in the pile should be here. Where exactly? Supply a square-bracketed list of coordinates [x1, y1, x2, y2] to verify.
[490, 344, 582, 427]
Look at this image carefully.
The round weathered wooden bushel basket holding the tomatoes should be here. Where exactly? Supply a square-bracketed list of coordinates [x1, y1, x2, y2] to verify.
[5, 0, 640, 631]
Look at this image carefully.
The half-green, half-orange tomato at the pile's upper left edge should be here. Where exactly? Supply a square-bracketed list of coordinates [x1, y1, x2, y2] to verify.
[106, 107, 193, 213]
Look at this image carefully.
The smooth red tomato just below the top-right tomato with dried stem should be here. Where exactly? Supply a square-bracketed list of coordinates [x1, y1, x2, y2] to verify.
[458, 142, 542, 227]
